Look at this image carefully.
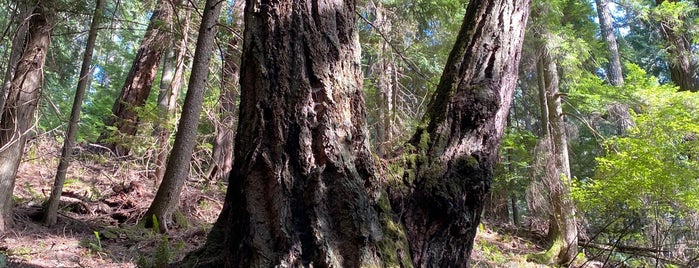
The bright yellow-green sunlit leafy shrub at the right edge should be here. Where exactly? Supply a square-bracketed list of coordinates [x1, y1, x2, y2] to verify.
[578, 78, 699, 215]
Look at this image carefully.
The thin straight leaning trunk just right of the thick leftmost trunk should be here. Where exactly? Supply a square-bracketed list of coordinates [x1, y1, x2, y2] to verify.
[43, 0, 105, 226]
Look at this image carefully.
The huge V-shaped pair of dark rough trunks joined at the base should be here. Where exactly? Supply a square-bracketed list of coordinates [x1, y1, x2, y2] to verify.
[182, 0, 529, 267]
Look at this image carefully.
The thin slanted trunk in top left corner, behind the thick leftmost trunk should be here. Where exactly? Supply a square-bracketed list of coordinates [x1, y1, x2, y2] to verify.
[0, 1, 33, 112]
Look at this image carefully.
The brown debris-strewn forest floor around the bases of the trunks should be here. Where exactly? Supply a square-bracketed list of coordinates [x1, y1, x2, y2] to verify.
[0, 137, 596, 268]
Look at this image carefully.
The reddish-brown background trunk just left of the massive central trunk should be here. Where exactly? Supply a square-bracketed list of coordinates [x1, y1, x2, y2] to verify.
[209, 37, 240, 181]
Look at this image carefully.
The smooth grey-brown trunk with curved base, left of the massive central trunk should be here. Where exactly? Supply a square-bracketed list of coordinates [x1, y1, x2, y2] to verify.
[142, 0, 223, 232]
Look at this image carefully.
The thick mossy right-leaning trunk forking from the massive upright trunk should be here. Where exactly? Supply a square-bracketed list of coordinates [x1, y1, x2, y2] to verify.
[394, 0, 530, 267]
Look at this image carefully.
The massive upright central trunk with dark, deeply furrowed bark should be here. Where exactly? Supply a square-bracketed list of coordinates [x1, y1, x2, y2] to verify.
[180, 0, 382, 267]
